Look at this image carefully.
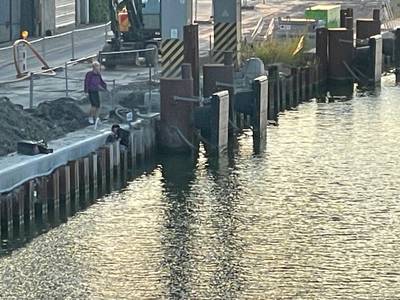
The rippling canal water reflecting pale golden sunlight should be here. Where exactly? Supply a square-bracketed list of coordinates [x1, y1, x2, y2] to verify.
[0, 77, 400, 299]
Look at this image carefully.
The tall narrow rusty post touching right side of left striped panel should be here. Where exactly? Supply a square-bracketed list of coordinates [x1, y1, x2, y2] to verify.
[183, 24, 200, 96]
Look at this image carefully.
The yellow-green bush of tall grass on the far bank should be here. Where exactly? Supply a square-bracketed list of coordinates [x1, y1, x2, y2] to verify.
[242, 37, 306, 66]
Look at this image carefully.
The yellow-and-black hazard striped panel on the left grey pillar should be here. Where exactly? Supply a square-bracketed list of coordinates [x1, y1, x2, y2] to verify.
[161, 39, 184, 78]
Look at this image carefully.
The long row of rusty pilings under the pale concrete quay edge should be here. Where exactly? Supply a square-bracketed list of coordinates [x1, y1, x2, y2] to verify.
[0, 121, 156, 245]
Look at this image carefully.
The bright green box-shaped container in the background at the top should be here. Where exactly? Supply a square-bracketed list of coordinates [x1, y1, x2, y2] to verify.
[305, 5, 340, 28]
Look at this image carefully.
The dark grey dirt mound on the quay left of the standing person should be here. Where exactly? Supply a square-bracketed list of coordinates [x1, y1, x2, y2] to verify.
[0, 98, 88, 156]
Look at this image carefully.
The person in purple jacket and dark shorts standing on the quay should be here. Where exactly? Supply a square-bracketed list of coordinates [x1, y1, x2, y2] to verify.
[85, 61, 107, 128]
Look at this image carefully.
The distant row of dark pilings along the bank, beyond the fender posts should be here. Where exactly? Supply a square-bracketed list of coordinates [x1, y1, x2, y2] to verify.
[268, 64, 326, 122]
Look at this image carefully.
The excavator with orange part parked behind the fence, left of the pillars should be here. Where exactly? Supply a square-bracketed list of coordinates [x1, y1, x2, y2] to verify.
[99, 0, 161, 68]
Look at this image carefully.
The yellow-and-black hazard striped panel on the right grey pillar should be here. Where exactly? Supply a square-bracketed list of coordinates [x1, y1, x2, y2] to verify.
[213, 23, 238, 63]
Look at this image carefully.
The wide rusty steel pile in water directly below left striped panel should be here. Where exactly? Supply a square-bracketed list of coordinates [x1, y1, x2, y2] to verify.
[160, 64, 198, 152]
